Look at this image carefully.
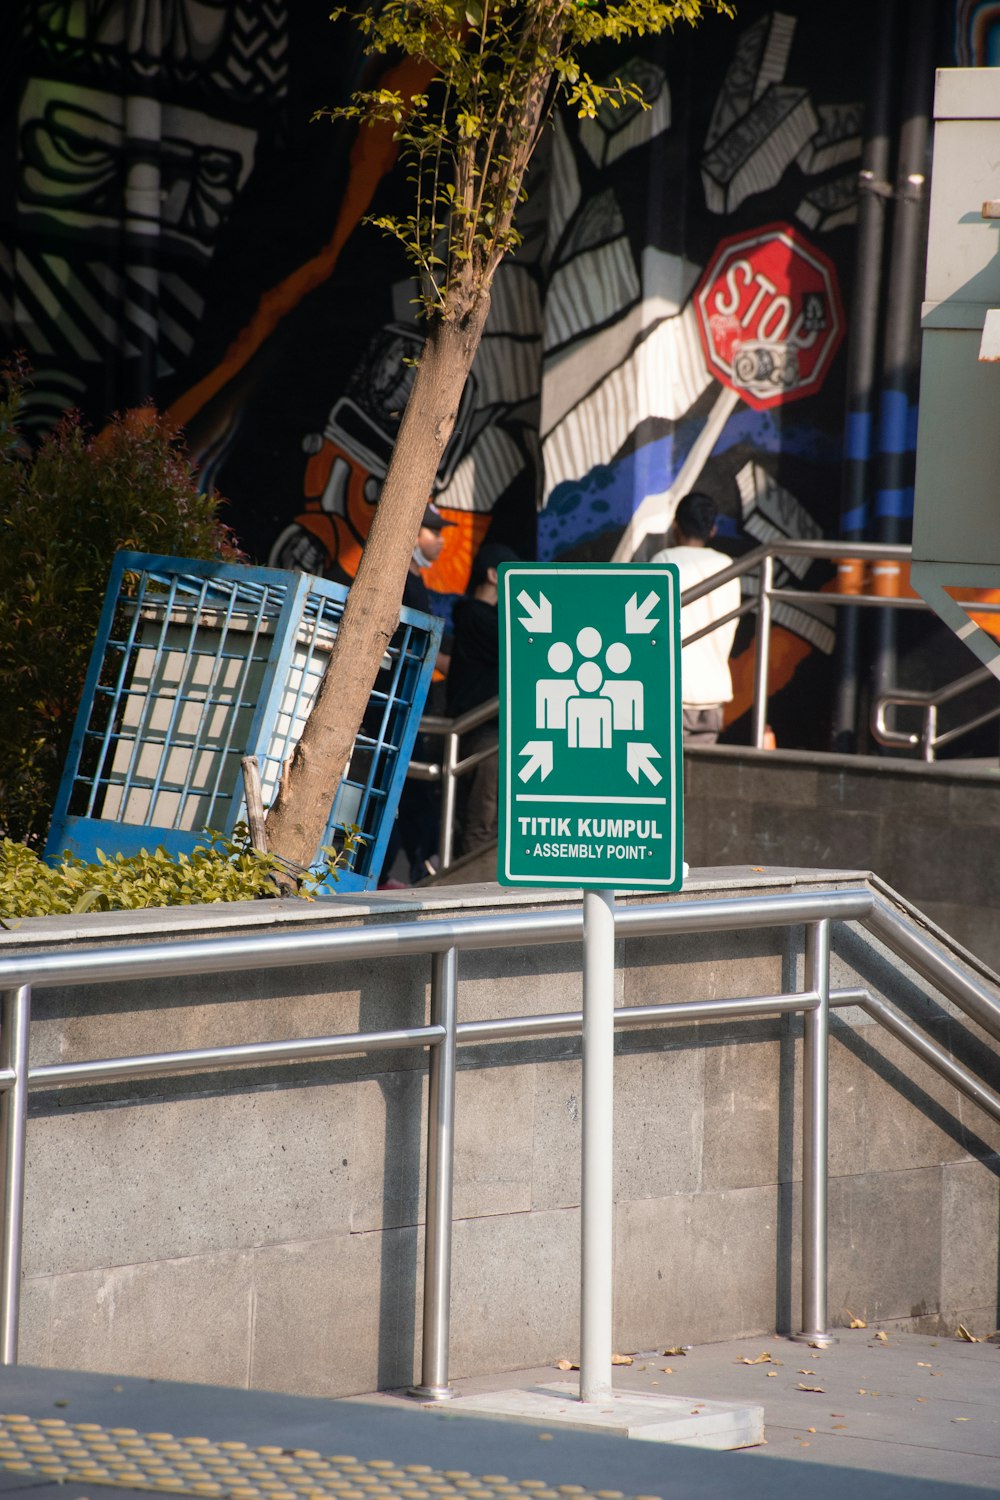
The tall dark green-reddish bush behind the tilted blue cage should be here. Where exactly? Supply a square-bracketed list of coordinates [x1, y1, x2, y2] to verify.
[0, 366, 240, 845]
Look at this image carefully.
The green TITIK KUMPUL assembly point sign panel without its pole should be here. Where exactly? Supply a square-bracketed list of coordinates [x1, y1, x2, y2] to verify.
[498, 563, 684, 891]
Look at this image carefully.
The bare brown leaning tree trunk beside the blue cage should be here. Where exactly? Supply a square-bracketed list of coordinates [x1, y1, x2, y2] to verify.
[267, 291, 490, 866]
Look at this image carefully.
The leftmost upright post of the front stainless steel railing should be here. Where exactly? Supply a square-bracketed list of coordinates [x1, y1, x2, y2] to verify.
[0, 984, 31, 1365]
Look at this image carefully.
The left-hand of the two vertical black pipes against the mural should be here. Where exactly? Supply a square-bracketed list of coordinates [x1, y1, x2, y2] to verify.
[831, 0, 898, 755]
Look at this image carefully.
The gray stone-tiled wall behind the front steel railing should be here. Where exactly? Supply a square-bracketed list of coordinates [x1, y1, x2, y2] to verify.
[0, 870, 1000, 1395]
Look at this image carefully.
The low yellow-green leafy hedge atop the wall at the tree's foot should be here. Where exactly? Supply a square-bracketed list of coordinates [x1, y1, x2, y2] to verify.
[0, 824, 361, 927]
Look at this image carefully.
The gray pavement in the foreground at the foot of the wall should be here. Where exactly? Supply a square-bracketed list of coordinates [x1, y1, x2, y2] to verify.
[0, 1331, 1000, 1500]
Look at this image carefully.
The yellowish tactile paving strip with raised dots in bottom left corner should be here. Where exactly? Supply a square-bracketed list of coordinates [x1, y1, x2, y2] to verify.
[0, 1413, 660, 1500]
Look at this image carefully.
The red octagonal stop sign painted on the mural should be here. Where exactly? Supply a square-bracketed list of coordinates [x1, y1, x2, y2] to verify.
[694, 224, 844, 411]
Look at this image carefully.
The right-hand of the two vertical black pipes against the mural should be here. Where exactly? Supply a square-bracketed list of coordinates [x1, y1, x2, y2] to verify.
[871, 0, 937, 720]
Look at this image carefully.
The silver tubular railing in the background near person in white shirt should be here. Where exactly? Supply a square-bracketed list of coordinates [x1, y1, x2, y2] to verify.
[408, 540, 1000, 873]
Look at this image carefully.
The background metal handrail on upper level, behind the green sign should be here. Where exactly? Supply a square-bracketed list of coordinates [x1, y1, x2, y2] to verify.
[408, 539, 1000, 872]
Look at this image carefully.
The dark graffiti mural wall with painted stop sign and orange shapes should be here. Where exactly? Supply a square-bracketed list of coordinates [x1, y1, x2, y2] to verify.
[0, 0, 971, 747]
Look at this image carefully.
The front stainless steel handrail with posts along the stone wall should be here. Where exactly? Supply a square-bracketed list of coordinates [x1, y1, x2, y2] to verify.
[0, 887, 1000, 1398]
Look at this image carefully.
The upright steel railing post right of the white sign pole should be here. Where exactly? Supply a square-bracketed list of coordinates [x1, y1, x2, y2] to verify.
[798, 920, 837, 1344]
